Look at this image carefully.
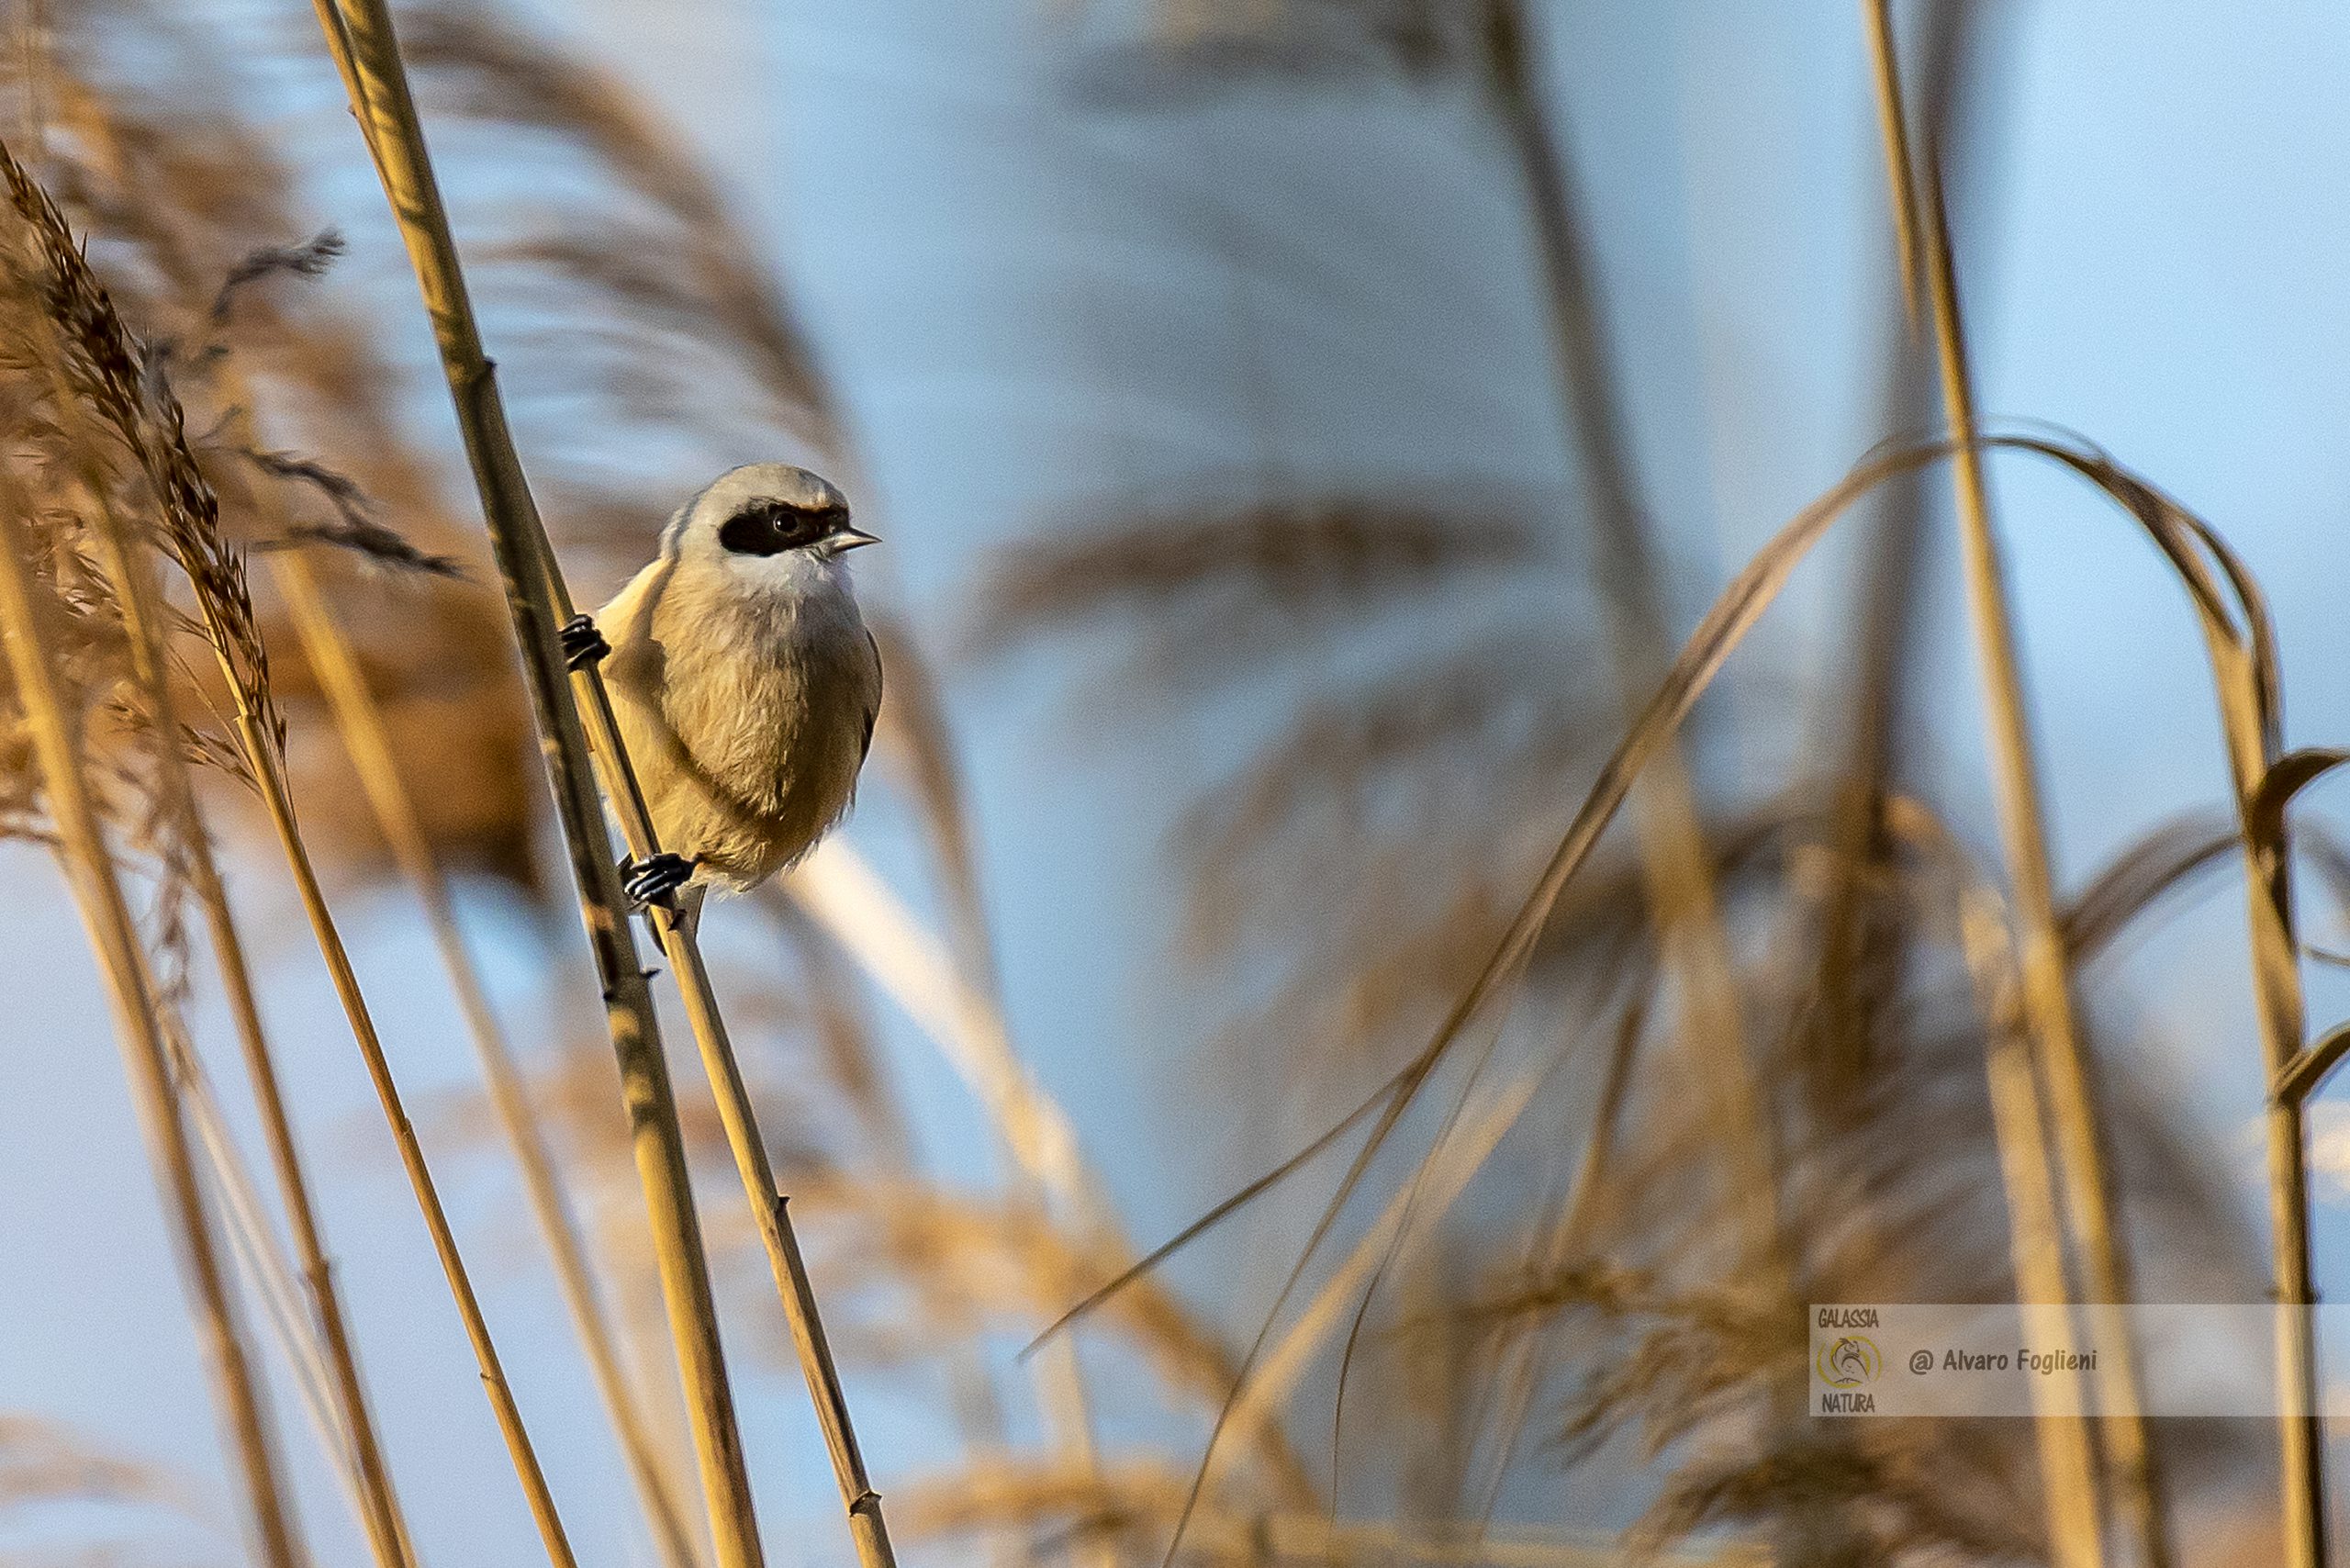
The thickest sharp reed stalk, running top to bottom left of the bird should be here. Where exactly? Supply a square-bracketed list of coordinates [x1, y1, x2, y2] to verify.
[303, 0, 794, 1568]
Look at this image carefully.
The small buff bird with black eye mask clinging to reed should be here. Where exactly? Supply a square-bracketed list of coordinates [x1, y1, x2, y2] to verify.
[582, 463, 881, 917]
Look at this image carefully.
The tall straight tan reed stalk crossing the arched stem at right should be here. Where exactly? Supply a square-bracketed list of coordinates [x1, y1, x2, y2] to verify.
[1862, 0, 2171, 1568]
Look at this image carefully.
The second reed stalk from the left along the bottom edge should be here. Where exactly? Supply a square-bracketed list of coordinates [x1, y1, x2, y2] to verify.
[81, 512, 408, 1568]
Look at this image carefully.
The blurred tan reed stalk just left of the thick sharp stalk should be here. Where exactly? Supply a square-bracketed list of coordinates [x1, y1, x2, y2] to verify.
[270, 550, 696, 1568]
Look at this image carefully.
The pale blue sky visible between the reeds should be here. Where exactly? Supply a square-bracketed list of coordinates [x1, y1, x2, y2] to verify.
[0, 0, 2350, 1563]
